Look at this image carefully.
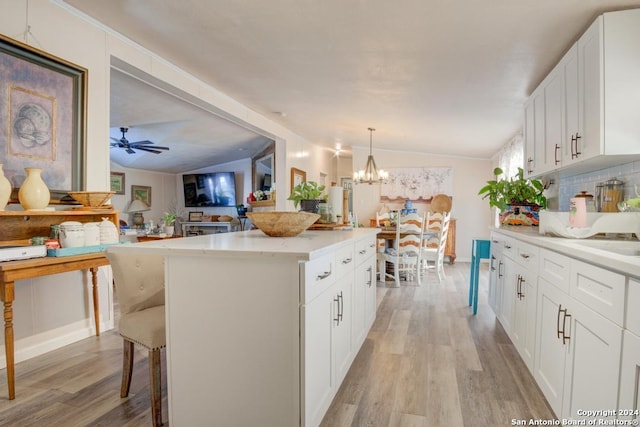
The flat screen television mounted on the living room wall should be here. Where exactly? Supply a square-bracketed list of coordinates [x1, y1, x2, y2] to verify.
[182, 172, 236, 208]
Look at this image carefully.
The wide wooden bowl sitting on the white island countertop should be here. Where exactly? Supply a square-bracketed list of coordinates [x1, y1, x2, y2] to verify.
[247, 211, 320, 237]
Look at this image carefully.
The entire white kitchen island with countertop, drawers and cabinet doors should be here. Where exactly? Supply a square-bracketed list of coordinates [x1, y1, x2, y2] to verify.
[108, 228, 377, 427]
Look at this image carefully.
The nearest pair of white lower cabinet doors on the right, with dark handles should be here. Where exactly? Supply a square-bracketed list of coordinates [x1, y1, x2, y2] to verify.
[534, 262, 622, 418]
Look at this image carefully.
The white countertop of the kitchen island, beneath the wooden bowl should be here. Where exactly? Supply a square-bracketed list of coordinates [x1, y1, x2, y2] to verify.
[107, 228, 379, 261]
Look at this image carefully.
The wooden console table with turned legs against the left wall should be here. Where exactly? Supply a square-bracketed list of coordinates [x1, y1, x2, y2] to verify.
[0, 252, 109, 400]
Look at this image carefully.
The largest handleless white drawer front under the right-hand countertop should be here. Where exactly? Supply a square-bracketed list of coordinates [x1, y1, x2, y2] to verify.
[569, 259, 626, 326]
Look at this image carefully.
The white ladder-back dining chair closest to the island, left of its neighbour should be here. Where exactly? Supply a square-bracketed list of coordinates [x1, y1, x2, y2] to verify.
[381, 213, 424, 287]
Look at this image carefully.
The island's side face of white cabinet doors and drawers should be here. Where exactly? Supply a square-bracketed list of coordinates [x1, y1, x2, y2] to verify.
[301, 238, 376, 427]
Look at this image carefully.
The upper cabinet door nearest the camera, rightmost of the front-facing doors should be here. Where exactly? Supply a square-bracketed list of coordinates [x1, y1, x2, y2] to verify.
[578, 17, 603, 159]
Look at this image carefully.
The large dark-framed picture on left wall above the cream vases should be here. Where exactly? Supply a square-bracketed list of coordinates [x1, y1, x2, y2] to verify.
[0, 35, 87, 203]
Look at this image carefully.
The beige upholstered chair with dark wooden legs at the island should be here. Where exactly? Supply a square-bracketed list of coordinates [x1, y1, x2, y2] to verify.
[106, 251, 166, 426]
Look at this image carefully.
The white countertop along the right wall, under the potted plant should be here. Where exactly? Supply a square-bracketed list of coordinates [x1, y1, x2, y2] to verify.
[493, 226, 640, 278]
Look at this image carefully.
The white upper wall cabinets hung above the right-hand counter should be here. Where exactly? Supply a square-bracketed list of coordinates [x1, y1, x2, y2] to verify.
[524, 9, 640, 176]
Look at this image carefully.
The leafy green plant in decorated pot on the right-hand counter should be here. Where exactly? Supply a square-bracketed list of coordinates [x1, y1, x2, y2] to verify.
[478, 168, 547, 225]
